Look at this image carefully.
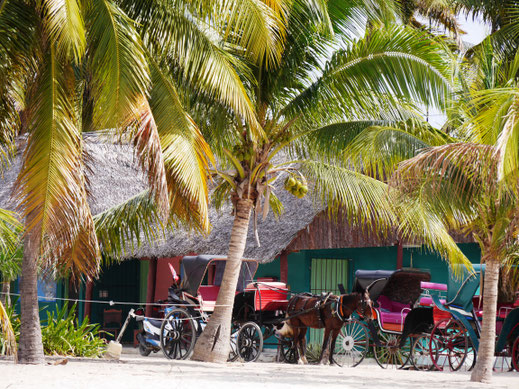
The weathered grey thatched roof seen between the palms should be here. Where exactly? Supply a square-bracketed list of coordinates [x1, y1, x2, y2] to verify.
[0, 136, 321, 261]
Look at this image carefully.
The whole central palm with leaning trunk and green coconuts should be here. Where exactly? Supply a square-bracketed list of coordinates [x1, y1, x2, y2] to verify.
[192, 1, 472, 362]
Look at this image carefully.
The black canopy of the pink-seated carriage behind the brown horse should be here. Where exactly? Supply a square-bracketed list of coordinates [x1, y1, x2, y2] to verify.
[353, 269, 431, 305]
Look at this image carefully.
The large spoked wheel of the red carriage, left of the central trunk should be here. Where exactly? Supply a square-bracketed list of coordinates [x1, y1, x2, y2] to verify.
[160, 308, 196, 359]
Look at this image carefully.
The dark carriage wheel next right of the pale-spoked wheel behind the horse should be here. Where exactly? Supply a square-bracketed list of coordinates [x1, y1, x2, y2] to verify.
[373, 332, 411, 369]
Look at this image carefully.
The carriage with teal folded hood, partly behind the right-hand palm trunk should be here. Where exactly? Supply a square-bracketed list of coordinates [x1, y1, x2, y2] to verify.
[424, 265, 519, 371]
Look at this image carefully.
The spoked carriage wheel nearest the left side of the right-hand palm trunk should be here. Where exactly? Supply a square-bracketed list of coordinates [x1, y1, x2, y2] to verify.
[429, 317, 475, 371]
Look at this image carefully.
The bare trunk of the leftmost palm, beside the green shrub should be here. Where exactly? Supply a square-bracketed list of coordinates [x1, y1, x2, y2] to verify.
[18, 234, 45, 364]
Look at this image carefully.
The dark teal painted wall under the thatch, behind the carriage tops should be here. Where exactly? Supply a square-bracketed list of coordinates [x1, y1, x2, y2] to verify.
[256, 243, 481, 292]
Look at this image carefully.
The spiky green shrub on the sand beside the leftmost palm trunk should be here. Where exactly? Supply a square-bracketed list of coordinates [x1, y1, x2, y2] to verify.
[41, 304, 105, 357]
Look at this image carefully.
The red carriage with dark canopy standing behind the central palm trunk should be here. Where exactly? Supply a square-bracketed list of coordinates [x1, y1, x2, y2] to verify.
[154, 255, 288, 362]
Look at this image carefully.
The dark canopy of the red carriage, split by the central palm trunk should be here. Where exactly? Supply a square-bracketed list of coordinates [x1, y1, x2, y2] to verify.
[180, 255, 258, 296]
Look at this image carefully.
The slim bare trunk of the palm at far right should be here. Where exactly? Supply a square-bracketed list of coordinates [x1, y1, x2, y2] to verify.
[470, 259, 499, 383]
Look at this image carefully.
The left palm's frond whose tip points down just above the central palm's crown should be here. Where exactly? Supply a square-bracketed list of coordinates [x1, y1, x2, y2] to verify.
[123, 1, 260, 131]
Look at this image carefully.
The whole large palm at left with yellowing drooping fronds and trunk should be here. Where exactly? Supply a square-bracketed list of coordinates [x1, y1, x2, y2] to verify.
[0, 0, 279, 363]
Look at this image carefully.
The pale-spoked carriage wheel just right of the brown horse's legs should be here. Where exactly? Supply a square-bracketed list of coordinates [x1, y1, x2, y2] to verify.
[333, 319, 369, 367]
